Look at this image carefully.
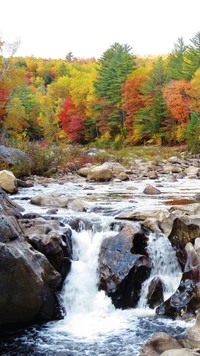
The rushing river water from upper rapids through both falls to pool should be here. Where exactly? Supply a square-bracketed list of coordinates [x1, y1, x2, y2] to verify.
[0, 179, 197, 356]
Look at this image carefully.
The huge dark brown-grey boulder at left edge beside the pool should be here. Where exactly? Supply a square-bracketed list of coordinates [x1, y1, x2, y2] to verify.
[0, 217, 61, 325]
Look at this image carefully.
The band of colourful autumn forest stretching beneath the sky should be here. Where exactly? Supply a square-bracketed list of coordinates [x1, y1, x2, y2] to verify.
[0, 32, 200, 152]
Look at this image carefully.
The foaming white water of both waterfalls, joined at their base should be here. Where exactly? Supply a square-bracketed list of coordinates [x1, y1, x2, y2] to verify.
[53, 225, 181, 340]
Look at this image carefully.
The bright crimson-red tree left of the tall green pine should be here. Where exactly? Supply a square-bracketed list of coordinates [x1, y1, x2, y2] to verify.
[58, 95, 84, 142]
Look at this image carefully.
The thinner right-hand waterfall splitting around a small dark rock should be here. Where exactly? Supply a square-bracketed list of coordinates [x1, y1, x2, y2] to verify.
[138, 233, 182, 308]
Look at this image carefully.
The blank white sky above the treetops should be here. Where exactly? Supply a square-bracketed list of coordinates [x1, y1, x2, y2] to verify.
[0, 0, 200, 59]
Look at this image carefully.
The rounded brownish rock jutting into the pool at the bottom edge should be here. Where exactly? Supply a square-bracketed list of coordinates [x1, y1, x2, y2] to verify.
[140, 332, 183, 356]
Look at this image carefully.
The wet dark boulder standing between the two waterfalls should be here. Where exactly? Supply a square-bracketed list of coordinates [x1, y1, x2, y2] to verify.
[99, 224, 151, 308]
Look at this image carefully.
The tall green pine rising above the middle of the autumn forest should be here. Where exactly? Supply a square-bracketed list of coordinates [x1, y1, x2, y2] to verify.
[94, 43, 135, 136]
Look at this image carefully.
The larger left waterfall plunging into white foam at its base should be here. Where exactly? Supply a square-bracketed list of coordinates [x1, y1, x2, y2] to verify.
[52, 217, 130, 338]
